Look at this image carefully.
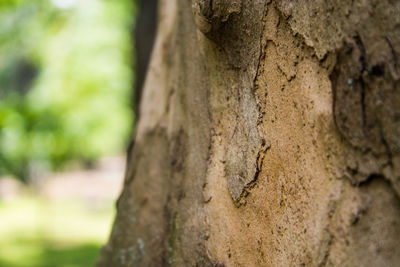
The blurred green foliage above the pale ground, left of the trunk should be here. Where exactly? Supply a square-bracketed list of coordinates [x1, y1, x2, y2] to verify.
[0, 0, 134, 181]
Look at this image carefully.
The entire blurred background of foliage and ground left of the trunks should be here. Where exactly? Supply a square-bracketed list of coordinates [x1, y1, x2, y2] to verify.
[0, 0, 136, 267]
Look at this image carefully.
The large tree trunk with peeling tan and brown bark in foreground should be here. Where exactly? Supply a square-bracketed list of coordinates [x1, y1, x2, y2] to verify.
[98, 0, 400, 266]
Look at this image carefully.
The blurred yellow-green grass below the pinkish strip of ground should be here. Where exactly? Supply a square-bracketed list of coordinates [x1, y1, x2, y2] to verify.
[0, 196, 113, 267]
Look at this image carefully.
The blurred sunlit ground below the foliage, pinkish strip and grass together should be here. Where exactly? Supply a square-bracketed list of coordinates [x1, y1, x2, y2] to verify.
[0, 157, 124, 267]
